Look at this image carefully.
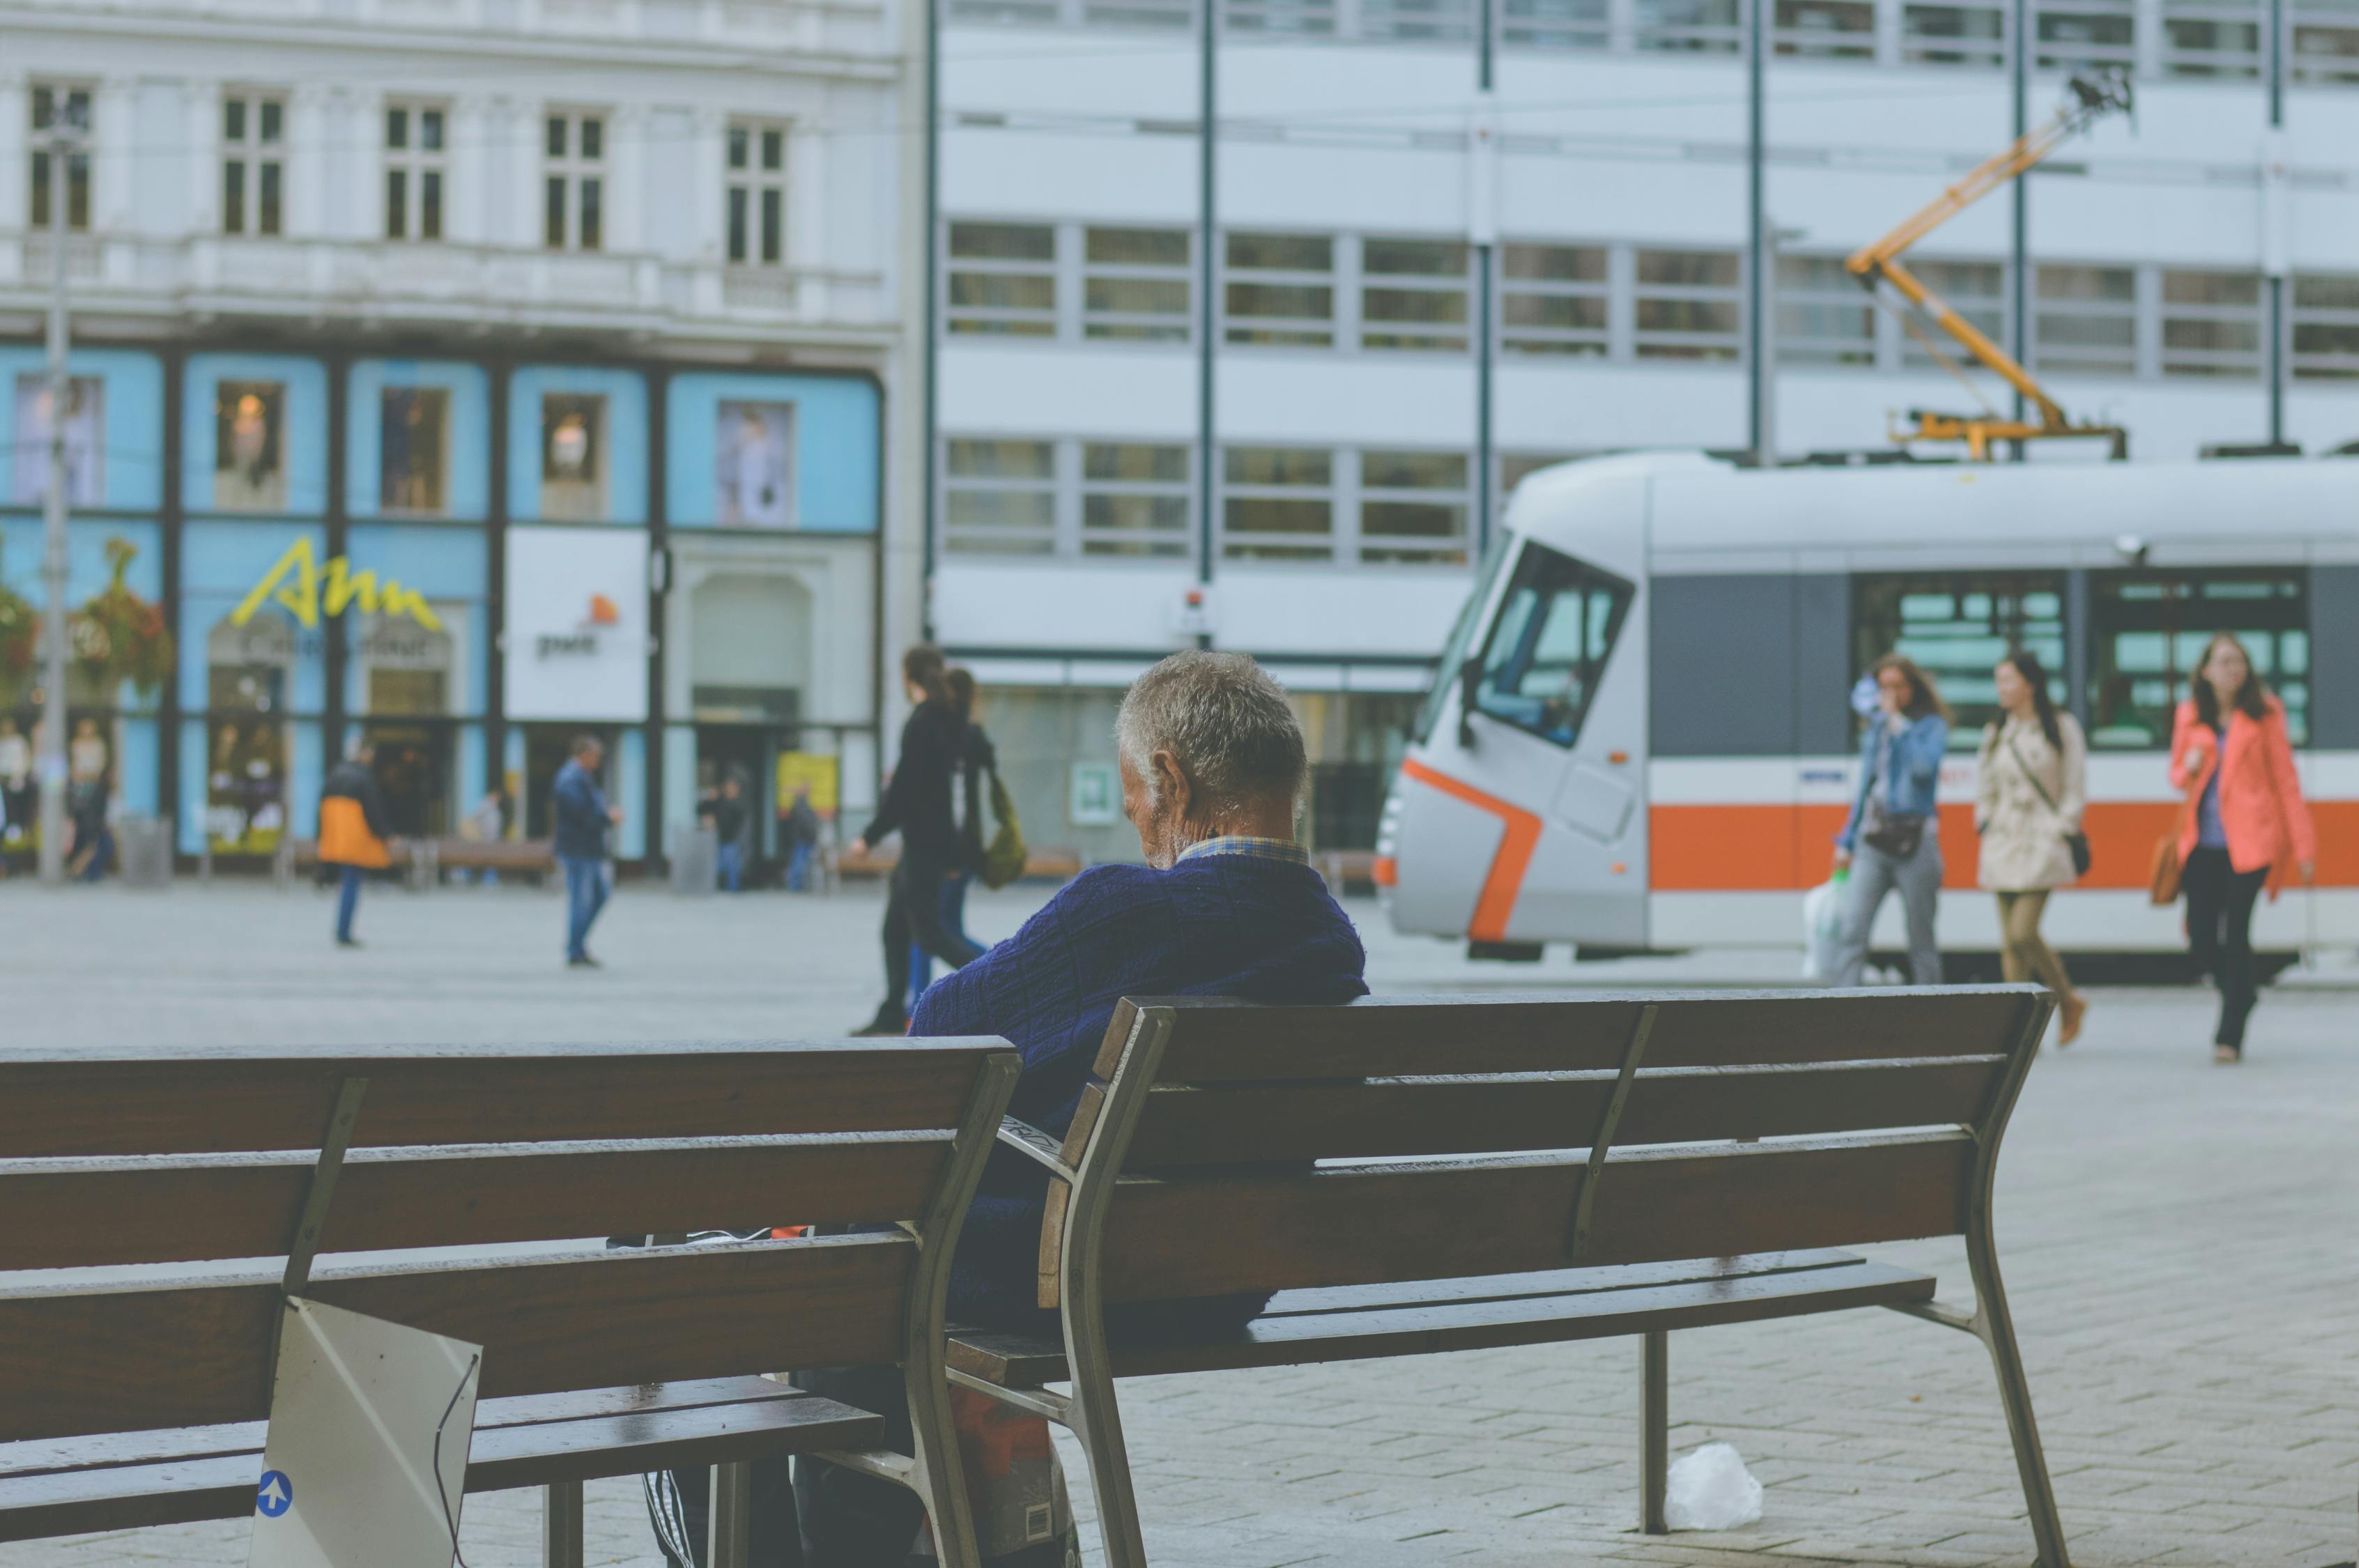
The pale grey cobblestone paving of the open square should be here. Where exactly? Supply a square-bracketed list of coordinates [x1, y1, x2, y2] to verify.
[0, 884, 2359, 1568]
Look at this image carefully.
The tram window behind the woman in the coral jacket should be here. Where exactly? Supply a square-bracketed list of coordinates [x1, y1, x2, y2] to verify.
[2088, 566, 2310, 750]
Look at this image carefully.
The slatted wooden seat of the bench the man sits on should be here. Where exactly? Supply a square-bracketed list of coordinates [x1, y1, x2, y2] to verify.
[951, 1254, 1935, 1389]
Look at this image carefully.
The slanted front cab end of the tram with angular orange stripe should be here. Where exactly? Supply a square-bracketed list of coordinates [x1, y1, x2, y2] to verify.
[1394, 479, 1647, 948]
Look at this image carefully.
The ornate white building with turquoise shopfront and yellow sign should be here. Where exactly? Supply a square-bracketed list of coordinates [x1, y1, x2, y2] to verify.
[0, 0, 923, 861]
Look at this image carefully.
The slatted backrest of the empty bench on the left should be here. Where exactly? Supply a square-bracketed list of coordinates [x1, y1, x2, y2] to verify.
[0, 1040, 1019, 1443]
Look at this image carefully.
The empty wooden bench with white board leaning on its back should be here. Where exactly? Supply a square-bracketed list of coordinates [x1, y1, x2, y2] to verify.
[0, 1040, 1019, 1568]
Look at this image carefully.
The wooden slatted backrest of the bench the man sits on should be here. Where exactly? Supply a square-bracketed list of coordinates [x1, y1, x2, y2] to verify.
[1040, 985, 2052, 1306]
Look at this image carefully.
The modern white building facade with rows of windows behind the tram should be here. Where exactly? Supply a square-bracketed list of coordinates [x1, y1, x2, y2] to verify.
[930, 0, 2359, 854]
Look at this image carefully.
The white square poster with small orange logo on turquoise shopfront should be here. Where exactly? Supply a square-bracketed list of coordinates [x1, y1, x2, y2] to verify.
[502, 528, 646, 724]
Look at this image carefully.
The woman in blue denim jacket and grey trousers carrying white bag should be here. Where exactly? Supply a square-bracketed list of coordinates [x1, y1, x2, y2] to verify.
[1833, 653, 1949, 985]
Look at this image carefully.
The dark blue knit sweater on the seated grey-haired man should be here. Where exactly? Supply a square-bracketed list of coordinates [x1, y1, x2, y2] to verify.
[908, 854, 1368, 1328]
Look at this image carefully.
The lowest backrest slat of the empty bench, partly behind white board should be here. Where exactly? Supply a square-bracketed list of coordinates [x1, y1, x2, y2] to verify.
[0, 1233, 913, 1440]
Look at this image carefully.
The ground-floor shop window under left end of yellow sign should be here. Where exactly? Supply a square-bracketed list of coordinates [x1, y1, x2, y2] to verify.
[205, 615, 295, 854]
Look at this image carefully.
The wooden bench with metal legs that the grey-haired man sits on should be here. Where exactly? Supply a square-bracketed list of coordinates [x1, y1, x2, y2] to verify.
[951, 985, 2066, 1568]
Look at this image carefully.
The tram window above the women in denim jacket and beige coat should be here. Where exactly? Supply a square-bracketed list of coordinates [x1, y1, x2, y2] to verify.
[1852, 571, 2066, 752]
